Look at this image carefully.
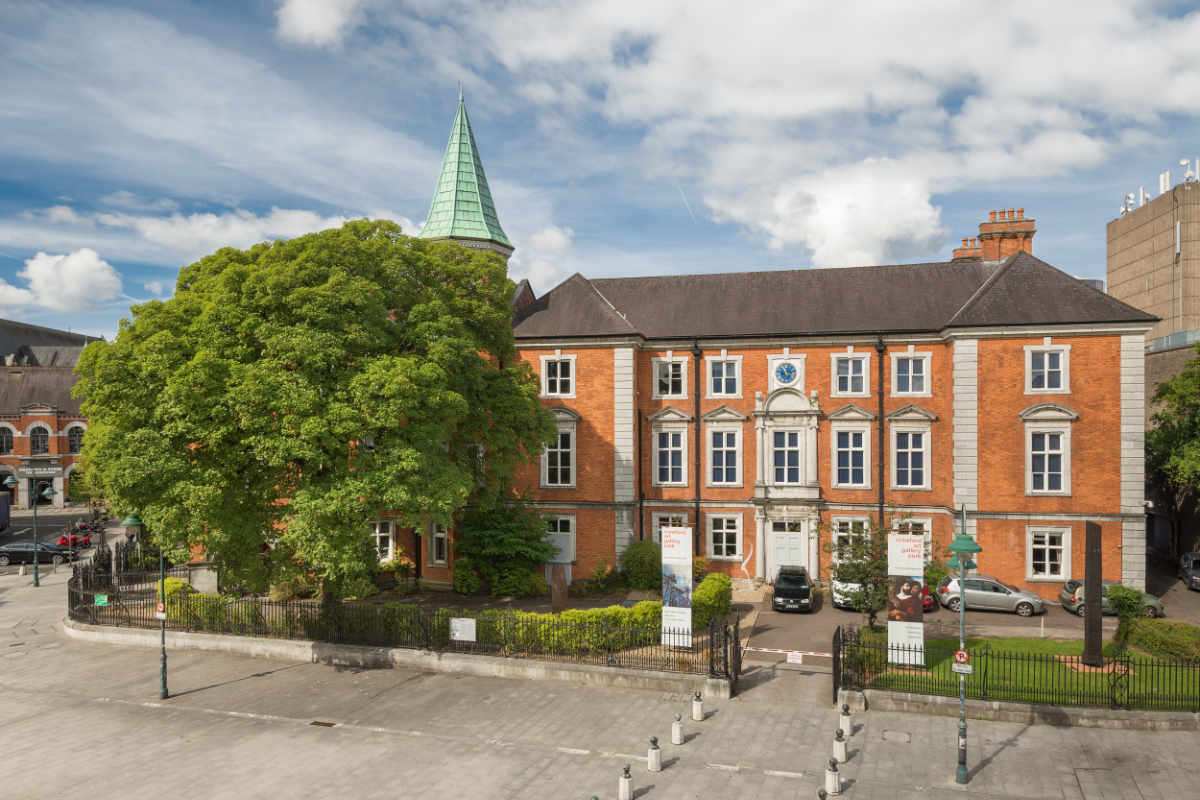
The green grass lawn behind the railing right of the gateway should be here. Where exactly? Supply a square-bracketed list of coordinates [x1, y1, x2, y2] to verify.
[847, 631, 1200, 711]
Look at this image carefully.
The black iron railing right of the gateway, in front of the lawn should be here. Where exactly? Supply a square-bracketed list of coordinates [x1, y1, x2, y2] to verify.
[834, 628, 1200, 711]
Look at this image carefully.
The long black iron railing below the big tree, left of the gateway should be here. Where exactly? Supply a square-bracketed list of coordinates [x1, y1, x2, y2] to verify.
[67, 565, 740, 678]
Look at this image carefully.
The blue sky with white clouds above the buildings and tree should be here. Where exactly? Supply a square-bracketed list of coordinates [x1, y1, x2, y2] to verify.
[0, 0, 1200, 337]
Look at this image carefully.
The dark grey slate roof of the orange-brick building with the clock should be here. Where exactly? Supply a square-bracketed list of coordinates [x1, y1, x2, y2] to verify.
[514, 252, 1156, 339]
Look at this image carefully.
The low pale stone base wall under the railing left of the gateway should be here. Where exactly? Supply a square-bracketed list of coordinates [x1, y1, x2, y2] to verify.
[62, 618, 730, 699]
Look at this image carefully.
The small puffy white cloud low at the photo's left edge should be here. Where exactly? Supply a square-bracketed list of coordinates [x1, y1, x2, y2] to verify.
[0, 247, 121, 311]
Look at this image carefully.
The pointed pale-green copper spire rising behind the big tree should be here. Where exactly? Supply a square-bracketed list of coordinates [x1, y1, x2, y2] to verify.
[421, 90, 512, 254]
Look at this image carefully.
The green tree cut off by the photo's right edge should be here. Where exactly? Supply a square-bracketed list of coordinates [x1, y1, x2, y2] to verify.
[1146, 345, 1200, 558]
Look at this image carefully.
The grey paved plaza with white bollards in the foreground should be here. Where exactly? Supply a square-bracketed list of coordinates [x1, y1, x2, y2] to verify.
[0, 572, 1200, 800]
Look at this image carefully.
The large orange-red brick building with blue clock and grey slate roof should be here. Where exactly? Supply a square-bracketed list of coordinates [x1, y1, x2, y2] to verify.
[504, 235, 1153, 597]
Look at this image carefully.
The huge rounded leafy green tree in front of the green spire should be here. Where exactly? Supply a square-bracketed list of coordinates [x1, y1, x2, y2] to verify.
[76, 219, 552, 591]
